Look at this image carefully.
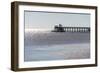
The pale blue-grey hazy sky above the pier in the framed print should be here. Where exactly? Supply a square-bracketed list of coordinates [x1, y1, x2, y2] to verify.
[24, 11, 90, 29]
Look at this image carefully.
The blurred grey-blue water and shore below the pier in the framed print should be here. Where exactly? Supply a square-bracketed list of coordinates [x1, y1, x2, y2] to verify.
[24, 30, 90, 61]
